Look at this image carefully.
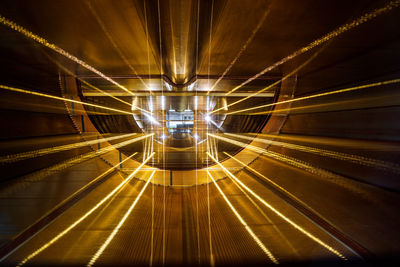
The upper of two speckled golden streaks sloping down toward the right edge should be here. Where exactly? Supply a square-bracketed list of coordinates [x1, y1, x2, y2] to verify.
[225, 133, 400, 173]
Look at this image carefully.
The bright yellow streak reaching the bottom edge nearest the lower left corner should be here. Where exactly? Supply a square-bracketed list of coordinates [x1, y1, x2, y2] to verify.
[17, 152, 155, 267]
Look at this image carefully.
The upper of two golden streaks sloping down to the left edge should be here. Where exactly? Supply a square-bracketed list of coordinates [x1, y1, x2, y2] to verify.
[0, 133, 136, 164]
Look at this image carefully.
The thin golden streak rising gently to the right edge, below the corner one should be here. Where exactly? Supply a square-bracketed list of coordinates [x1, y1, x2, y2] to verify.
[222, 79, 400, 115]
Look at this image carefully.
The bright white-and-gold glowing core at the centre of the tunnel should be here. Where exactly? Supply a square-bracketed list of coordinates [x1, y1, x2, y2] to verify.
[132, 92, 226, 148]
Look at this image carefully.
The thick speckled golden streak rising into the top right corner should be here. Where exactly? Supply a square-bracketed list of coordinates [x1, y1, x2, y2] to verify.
[222, 0, 400, 95]
